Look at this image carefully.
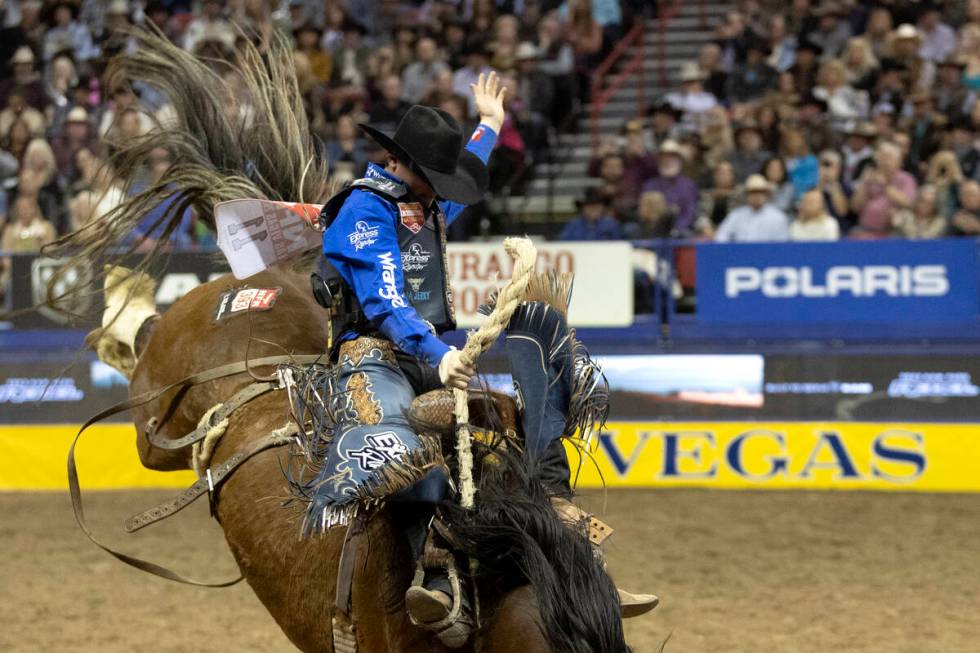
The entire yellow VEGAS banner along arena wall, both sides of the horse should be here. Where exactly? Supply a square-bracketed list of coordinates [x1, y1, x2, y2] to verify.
[0, 422, 980, 492]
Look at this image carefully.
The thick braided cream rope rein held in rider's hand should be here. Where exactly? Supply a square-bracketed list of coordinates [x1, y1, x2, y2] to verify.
[453, 238, 538, 508]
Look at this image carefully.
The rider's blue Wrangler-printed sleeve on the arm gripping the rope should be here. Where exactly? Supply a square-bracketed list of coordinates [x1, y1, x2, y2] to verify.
[323, 190, 449, 367]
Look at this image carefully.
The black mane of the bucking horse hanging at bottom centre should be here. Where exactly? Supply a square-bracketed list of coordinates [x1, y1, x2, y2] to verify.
[441, 451, 630, 653]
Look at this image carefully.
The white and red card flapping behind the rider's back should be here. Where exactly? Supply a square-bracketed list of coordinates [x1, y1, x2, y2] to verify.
[214, 200, 323, 279]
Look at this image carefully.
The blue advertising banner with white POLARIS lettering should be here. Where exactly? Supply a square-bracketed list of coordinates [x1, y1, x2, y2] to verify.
[697, 239, 980, 325]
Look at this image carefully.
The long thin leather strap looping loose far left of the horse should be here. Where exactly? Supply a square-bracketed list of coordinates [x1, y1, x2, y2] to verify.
[68, 354, 323, 587]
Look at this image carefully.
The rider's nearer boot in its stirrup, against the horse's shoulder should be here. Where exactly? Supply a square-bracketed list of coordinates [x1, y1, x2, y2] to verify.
[405, 529, 473, 648]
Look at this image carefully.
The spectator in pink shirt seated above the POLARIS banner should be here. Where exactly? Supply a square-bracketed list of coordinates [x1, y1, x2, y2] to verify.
[851, 141, 917, 238]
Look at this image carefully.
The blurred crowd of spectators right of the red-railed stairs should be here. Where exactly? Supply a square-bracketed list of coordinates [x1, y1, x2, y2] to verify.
[561, 0, 980, 242]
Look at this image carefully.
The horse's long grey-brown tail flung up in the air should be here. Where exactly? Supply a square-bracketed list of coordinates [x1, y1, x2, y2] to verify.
[46, 30, 330, 310]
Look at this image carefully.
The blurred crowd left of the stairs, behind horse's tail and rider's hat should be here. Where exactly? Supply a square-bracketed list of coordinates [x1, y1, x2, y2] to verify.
[0, 0, 648, 266]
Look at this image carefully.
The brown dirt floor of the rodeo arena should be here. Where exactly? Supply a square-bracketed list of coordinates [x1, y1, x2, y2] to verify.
[0, 490, 980, 653]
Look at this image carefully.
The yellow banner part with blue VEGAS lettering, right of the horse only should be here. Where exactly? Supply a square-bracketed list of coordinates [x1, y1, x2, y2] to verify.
[569, 422, 980, 492]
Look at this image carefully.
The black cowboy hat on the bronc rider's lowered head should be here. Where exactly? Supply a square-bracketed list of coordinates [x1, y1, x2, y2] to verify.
[358, 104, 489, 204]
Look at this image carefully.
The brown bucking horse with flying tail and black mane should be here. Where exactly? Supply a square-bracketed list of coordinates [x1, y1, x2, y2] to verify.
[51, 26, 652, 653]
